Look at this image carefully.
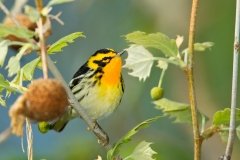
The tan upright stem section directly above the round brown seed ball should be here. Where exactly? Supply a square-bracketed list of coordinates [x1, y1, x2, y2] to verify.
[37, 17, 48, 79]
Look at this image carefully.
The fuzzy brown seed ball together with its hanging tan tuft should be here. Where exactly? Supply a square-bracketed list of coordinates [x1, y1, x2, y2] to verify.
[9, 79, 68, 136]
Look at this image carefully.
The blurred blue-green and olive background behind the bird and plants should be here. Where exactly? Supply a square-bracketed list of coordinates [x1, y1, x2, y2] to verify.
[0, 0, 240, 160]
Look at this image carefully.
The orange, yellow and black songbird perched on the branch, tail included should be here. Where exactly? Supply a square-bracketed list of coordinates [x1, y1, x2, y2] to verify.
[50, 48, 124, 132]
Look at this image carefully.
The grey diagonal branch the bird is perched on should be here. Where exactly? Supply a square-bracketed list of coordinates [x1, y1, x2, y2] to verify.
[47, 55, 111, 150]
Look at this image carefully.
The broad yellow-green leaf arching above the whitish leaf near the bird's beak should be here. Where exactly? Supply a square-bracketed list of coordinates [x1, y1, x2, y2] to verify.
[125, 31, 178, 57]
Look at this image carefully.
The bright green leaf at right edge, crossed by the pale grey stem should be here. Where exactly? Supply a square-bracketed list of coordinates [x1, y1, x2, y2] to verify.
[212, 108, 240, 125]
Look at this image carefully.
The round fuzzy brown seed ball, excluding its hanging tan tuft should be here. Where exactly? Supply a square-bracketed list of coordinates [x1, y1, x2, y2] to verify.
[23, 79, 68, 121]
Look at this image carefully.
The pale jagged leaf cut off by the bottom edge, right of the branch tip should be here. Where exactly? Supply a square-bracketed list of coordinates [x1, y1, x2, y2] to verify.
[124, 141, 157, 160]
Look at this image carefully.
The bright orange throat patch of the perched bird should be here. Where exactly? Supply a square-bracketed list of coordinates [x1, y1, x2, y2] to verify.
[101, 57, 122, 86]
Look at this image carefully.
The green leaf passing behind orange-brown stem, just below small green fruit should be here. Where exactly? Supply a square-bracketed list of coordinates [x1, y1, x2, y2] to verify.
[153, 98, 209, 125]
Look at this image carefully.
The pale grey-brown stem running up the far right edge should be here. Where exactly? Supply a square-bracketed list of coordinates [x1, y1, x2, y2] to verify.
[224, 0, 240, 160]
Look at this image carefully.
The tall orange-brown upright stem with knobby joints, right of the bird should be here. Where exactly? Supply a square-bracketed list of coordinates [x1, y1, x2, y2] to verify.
[185, 0, 202, 160]
